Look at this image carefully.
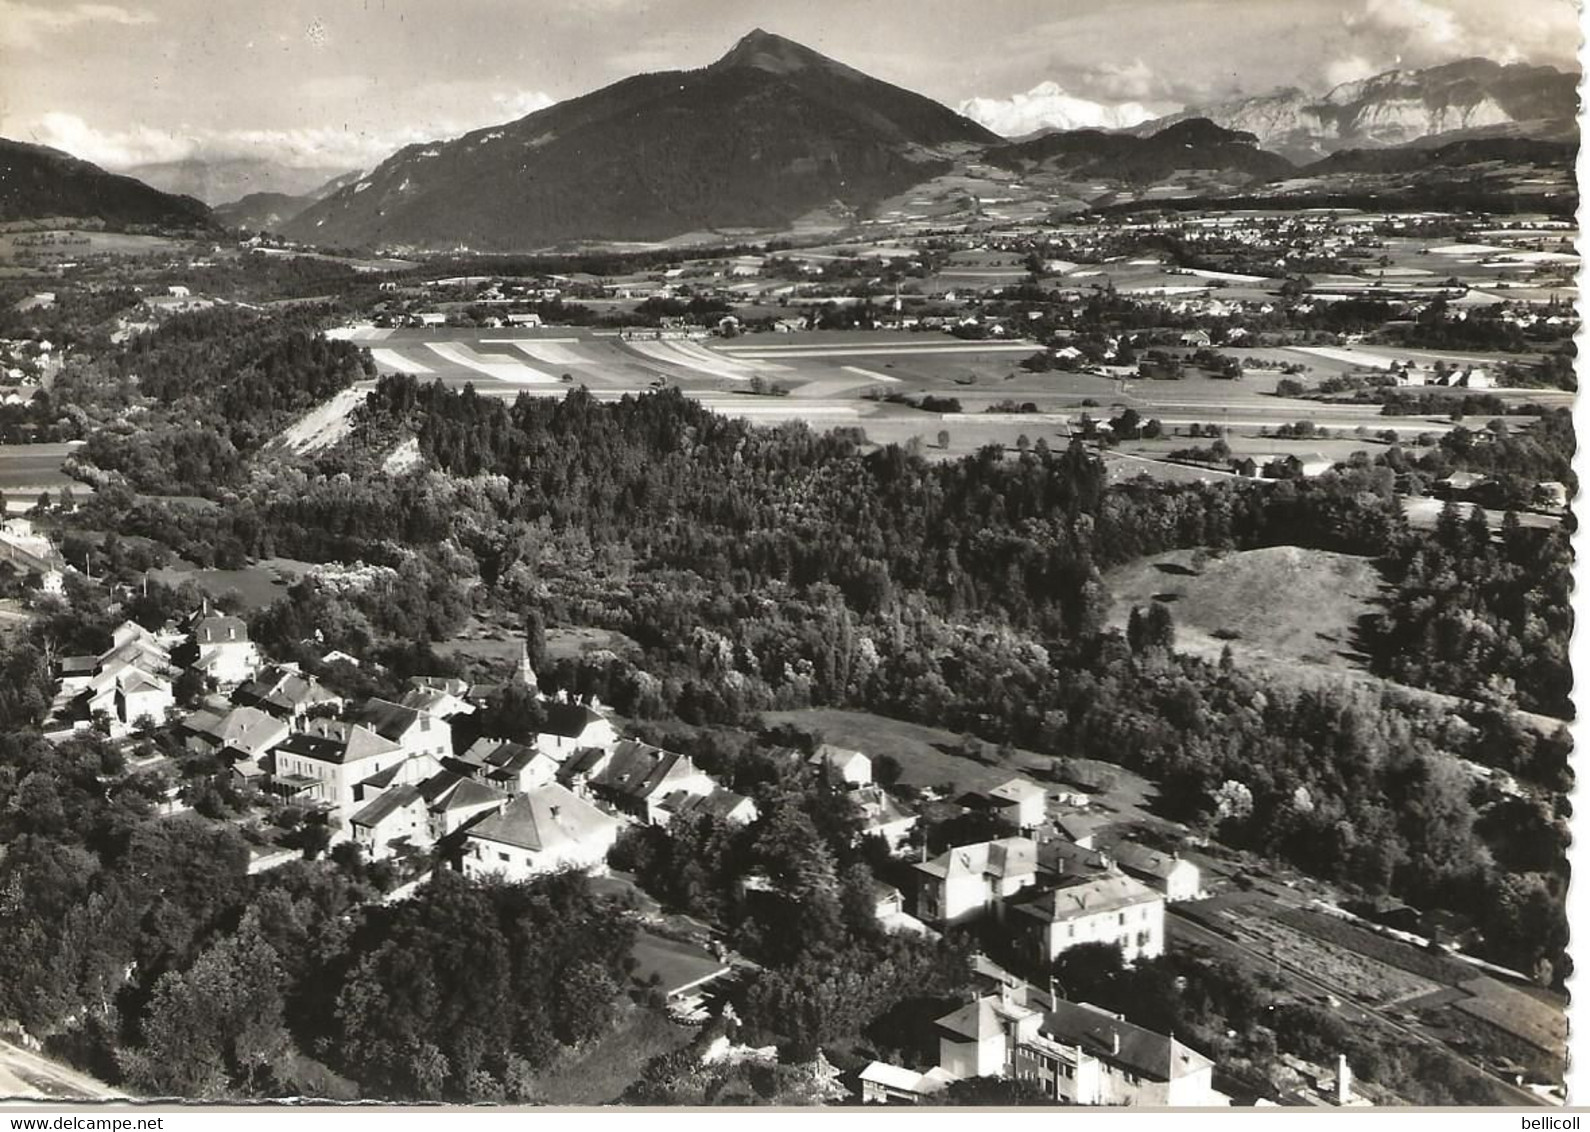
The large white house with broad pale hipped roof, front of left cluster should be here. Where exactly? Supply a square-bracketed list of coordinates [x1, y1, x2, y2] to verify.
[463, 784, 620, 881]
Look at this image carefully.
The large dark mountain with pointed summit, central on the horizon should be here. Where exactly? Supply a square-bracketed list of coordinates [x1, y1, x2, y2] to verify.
[273, 30, 1000, 250]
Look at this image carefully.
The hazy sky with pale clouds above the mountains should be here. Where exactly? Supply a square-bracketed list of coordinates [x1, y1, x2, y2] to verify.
[0, 0, 1580, 170]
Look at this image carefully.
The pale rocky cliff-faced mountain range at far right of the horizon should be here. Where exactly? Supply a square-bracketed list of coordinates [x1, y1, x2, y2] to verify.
[1130, 59, 1579, 164]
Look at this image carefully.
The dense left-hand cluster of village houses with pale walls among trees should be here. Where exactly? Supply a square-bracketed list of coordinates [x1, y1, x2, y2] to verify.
[52, 609, 769, 879]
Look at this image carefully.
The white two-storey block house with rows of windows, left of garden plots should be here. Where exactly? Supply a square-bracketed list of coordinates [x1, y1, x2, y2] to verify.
[1010, 873, 1165, 965]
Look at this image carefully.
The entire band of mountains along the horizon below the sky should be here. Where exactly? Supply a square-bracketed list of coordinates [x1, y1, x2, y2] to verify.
[0, 40, 1579, 251]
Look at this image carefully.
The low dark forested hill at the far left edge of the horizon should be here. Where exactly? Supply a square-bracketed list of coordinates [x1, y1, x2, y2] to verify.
[0, 138, 213, 227]
